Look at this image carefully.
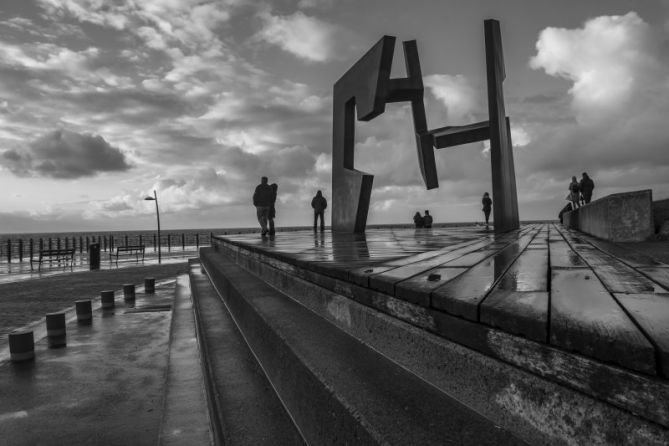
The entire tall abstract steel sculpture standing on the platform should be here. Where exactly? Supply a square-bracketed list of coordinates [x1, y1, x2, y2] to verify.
[332, 20, 519, 233]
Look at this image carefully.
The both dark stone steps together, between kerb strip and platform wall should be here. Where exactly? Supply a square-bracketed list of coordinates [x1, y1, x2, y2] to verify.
[190, 248, 524, 445]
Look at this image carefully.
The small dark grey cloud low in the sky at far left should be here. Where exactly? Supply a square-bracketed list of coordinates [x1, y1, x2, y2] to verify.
[2, 130, 130, 179]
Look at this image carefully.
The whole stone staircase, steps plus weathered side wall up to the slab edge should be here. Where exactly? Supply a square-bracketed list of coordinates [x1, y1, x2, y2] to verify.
[190, 232, 669, 445]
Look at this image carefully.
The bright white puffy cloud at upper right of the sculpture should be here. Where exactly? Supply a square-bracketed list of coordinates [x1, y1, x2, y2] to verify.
[530, 12, 667, 123]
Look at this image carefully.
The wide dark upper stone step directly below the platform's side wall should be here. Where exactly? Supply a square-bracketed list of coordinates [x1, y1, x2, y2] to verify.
[196, 249, 523, 445]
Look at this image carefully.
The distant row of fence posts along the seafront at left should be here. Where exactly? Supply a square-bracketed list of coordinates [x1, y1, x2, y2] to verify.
[0, 232, 211, 263]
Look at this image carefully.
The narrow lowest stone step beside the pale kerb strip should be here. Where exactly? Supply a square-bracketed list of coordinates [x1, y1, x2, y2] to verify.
[189, 263, 304, 446]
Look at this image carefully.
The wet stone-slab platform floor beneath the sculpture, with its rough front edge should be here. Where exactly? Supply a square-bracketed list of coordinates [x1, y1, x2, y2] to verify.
[215, 223, 669, 379]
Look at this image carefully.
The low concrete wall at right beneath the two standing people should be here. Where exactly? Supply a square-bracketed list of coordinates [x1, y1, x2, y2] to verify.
[562, 189, 655, 242]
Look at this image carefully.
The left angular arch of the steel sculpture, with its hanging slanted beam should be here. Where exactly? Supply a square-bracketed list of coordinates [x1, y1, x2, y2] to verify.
[332, 36, 438, 233]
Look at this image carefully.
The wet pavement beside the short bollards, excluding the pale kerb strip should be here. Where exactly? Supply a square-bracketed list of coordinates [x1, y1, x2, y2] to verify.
[0, 280, 175, 445]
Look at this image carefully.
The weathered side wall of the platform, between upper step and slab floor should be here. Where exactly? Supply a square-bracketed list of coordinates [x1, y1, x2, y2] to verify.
[201, 246, 669, 444]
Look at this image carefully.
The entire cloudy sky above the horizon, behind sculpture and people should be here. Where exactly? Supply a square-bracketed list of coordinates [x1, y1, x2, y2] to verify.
[0, 0, 669, 233]
